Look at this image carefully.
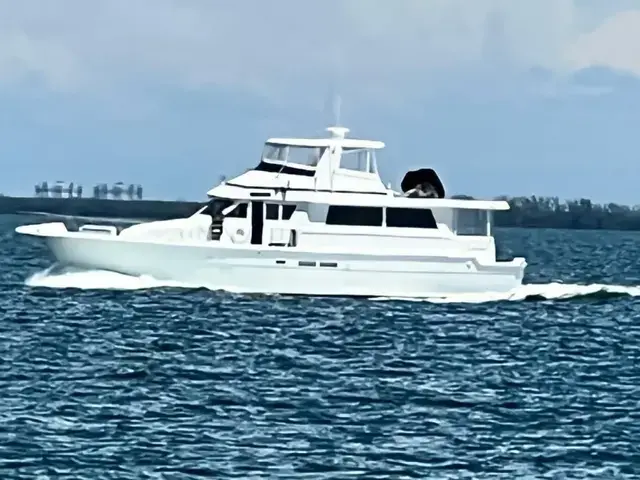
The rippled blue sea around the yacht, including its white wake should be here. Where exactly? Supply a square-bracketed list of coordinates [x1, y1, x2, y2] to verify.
[0, 217, 640, 480]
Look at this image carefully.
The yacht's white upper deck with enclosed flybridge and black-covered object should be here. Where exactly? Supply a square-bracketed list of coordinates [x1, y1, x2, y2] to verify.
[208, 126, 509, 210]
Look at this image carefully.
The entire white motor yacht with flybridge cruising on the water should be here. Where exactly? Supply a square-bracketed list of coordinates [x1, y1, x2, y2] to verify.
[16, 127, 526, 297]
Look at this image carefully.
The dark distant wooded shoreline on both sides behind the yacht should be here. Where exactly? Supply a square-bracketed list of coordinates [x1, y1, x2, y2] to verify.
[0, 196, 640, 231]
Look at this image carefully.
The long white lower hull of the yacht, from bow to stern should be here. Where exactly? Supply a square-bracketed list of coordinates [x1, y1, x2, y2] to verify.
[18, 226, 526, 298]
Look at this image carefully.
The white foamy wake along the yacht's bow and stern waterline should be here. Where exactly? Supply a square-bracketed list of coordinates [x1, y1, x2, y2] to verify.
[25, 265, 640, 303]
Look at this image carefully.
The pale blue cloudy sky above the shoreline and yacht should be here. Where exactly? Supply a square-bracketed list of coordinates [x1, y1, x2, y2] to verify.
[0, 0, 640, 204]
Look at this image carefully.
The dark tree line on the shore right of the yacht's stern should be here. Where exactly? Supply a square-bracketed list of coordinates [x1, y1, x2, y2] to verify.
[456, 195, 640, 230]
